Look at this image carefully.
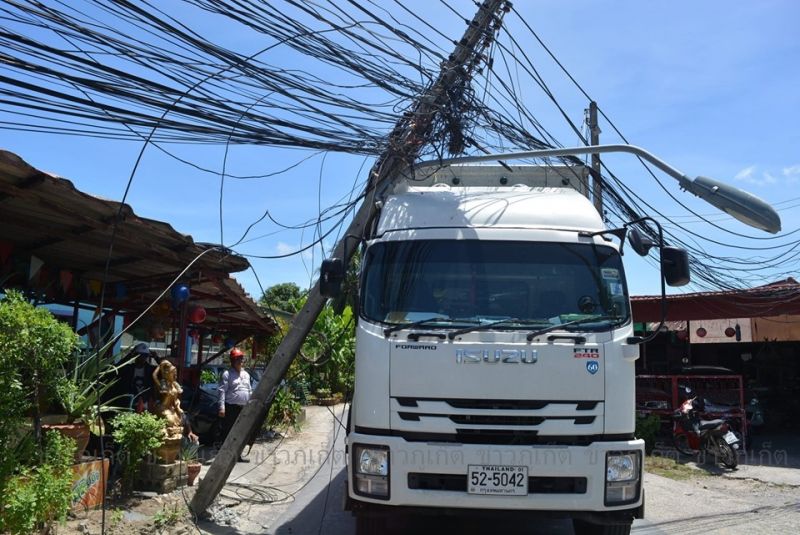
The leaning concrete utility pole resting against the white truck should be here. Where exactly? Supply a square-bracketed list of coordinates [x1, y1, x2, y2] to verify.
[190, 0, 510, 515]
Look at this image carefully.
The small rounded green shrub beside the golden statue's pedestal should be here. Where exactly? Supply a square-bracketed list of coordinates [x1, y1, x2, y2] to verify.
[111, 412, 167, 493]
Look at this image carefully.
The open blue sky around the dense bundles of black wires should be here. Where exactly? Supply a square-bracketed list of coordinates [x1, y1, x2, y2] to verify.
[0, 0, 800, 297]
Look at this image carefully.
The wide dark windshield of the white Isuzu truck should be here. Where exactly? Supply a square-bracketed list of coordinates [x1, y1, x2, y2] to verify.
[361, 240, 630, 331]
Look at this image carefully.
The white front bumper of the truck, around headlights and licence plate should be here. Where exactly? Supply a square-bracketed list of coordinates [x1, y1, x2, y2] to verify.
[347, 433, 644, 521]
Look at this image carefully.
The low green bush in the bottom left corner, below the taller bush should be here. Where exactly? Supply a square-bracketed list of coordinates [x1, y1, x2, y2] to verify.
[0, 431, 75, 535]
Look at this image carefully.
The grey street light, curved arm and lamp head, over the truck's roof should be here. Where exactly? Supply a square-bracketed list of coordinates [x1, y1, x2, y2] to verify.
[417, 145, 781, 234]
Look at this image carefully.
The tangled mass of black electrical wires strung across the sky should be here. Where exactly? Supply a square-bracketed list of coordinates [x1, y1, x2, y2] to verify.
[0, 0, 800, 298]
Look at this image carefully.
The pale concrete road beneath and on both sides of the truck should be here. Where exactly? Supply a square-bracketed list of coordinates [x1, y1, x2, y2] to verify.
[201, 406, 800, 535]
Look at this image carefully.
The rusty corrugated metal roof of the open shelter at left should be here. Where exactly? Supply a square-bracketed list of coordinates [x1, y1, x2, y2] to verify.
[0, 150, 274, 331]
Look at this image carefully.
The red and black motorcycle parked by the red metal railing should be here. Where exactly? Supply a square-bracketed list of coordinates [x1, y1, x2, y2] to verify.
[672, 397, 741, 469]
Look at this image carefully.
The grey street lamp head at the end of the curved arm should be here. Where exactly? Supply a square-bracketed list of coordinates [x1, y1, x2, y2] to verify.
[680, 176, 781, 234]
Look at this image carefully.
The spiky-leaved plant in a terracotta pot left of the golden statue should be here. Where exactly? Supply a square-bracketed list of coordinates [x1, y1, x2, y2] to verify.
[48, 353, 128, 460]
